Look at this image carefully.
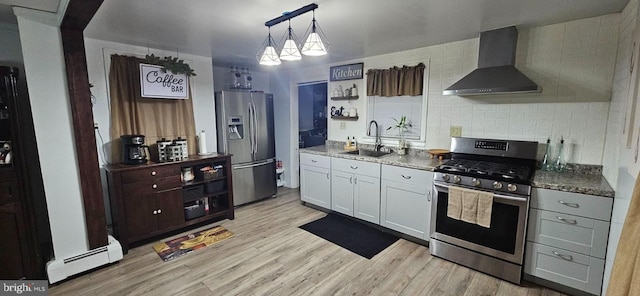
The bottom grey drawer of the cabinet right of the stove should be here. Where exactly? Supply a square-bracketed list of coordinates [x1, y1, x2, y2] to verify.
[524, 242, 604, 295]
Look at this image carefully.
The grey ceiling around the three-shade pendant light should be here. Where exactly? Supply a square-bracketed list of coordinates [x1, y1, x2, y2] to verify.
[0, 0, 628, 68]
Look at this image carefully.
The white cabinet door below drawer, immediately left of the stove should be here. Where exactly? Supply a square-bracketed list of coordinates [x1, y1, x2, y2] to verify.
[380, 180, 431, 239]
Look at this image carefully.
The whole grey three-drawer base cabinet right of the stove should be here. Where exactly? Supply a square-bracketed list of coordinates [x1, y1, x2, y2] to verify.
[524, 188, 613, 295]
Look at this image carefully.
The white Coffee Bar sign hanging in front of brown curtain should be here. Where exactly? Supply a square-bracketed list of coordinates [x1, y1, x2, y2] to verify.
[140, 64, 189, 99]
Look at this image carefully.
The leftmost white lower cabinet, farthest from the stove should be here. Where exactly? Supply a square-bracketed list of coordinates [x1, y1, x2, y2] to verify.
[300, 153, 331, 209]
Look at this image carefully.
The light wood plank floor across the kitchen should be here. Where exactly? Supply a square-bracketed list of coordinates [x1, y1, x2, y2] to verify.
[49, 189, 563, 296]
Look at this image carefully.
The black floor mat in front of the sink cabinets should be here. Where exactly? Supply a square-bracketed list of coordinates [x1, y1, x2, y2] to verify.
[300, 213, 398, 259]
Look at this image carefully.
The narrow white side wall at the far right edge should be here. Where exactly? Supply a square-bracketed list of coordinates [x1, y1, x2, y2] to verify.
[603, 0, 638, 291]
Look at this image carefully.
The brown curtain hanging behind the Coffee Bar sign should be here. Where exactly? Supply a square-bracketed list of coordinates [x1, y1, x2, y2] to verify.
[109, 55, 196, 163]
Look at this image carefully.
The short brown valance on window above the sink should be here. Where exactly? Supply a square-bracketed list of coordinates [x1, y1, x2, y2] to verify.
[367, 63, 425, 97]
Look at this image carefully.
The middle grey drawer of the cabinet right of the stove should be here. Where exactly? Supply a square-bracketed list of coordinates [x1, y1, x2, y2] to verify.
[527, 209, 609, 259]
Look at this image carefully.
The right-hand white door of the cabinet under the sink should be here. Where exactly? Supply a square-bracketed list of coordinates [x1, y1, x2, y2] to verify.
[353, 175, 380, 224]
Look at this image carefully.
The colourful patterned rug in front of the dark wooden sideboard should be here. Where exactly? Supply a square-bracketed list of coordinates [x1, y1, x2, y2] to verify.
[153, 226, 233, 262]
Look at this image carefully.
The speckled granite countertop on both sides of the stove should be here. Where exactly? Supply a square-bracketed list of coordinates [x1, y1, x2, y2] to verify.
[300, 145, 615, 197]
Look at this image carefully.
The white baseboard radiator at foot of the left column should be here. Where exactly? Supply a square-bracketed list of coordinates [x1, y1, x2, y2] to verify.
[47, 236, 122, 284]
